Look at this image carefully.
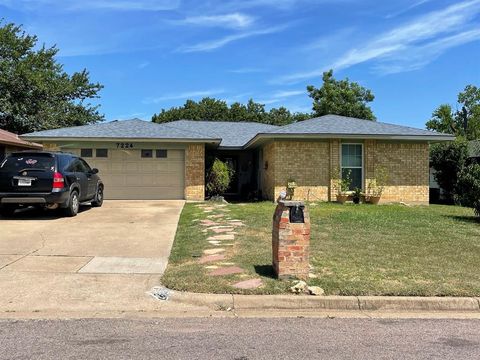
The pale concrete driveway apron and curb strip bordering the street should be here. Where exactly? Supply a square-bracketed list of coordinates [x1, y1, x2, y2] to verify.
[0, 273, 480, 318]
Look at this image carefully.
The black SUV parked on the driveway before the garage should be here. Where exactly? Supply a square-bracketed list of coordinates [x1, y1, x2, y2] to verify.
[0, 151, 104, 216]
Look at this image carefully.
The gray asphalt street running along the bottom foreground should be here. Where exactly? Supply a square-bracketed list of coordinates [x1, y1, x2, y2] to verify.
[0, 317, 480, 360]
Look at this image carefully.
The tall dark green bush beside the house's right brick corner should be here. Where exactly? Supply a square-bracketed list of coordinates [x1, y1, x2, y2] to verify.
[430, 140, 468, 203]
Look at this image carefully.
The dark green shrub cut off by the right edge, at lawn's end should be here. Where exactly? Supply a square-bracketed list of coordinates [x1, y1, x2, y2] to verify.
[456, 164, 480, 216]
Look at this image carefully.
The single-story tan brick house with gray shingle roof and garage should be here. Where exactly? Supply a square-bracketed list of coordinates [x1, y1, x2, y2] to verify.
[23, 115, 454, 203]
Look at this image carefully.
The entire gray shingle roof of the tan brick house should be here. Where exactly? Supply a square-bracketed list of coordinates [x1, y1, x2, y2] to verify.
[23, 115, 454, 148]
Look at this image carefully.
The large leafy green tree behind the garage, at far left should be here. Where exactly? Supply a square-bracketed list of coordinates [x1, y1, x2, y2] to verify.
[0, 20, 103, 133]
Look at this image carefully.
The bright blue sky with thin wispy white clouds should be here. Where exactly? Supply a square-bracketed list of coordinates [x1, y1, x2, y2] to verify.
[0, 0, 480, 128]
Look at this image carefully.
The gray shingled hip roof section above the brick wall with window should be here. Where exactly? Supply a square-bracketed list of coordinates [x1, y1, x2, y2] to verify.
[269, 115, 445, 139]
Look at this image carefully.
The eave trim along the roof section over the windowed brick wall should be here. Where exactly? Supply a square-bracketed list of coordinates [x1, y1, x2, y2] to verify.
[244, 133, 455, 149]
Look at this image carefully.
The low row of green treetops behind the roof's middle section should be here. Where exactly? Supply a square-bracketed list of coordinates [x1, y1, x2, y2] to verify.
[152, 97, 312, 125]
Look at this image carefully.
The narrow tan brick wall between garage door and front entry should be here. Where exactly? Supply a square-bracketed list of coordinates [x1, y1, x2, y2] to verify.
[185, 144, 205, 201]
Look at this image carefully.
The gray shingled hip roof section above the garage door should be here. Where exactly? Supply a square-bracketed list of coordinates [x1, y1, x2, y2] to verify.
[22, 119, 220, 142]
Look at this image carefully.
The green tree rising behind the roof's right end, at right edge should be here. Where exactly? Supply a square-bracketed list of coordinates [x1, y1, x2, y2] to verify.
[426, 85, 480, 140]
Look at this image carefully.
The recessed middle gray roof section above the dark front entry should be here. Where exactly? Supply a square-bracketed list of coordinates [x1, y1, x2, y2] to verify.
[164, 120, 279, 147]
